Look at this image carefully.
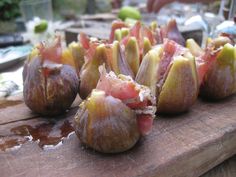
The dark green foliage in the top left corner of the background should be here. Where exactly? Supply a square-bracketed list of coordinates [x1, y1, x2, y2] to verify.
[0, 0, 20, 21]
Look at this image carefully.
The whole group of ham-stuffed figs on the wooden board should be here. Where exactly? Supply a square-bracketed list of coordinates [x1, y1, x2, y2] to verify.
[23, 20, 236, 153]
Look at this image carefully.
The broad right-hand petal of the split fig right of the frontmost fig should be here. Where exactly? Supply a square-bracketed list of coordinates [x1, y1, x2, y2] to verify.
[157, 56, 198, 114]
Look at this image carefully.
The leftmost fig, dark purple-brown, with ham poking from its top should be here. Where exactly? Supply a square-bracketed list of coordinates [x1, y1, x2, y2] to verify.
[23, 37, 79, 116]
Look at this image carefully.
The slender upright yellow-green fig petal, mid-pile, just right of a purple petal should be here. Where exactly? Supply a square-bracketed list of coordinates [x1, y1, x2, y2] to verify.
[125, 37, 140, 76]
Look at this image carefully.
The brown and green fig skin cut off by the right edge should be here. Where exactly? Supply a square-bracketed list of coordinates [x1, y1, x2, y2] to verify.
[200, 44, 236, 100]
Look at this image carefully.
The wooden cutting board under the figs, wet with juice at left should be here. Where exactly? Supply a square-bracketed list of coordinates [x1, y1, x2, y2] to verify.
[0, 93, 236, 177]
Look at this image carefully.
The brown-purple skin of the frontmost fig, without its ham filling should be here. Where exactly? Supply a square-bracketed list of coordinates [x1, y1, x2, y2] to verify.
[75, 90, 140, 153]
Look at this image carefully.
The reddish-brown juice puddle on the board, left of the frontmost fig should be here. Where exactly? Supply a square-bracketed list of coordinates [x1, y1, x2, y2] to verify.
[0, 120, 74, 151]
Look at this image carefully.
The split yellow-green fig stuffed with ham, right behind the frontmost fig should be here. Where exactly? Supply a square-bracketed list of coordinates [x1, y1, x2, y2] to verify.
[135, 39, 199, 114]
